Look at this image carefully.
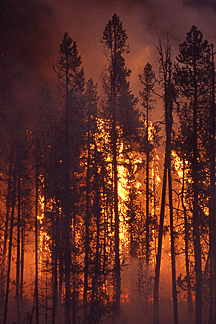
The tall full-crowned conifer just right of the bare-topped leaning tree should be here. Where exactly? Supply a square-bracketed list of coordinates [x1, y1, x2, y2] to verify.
[176, 26, 210, 324]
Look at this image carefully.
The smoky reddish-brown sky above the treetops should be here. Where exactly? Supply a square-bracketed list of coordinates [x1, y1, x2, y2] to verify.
[0, 0, 216, 116]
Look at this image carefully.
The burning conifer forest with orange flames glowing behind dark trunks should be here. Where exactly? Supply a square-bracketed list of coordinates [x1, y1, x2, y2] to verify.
[0, 14, 216, 324]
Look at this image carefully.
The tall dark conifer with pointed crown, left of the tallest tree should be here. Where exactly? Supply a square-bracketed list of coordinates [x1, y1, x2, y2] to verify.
[54, 33, 84, 324]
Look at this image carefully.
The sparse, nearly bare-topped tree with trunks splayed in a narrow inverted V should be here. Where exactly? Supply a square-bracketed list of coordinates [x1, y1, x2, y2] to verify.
[154, 39, 178, 324]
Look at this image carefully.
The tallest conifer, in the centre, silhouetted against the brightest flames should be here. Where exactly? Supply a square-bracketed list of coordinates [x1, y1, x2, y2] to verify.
[101, 13, 136, 313]
